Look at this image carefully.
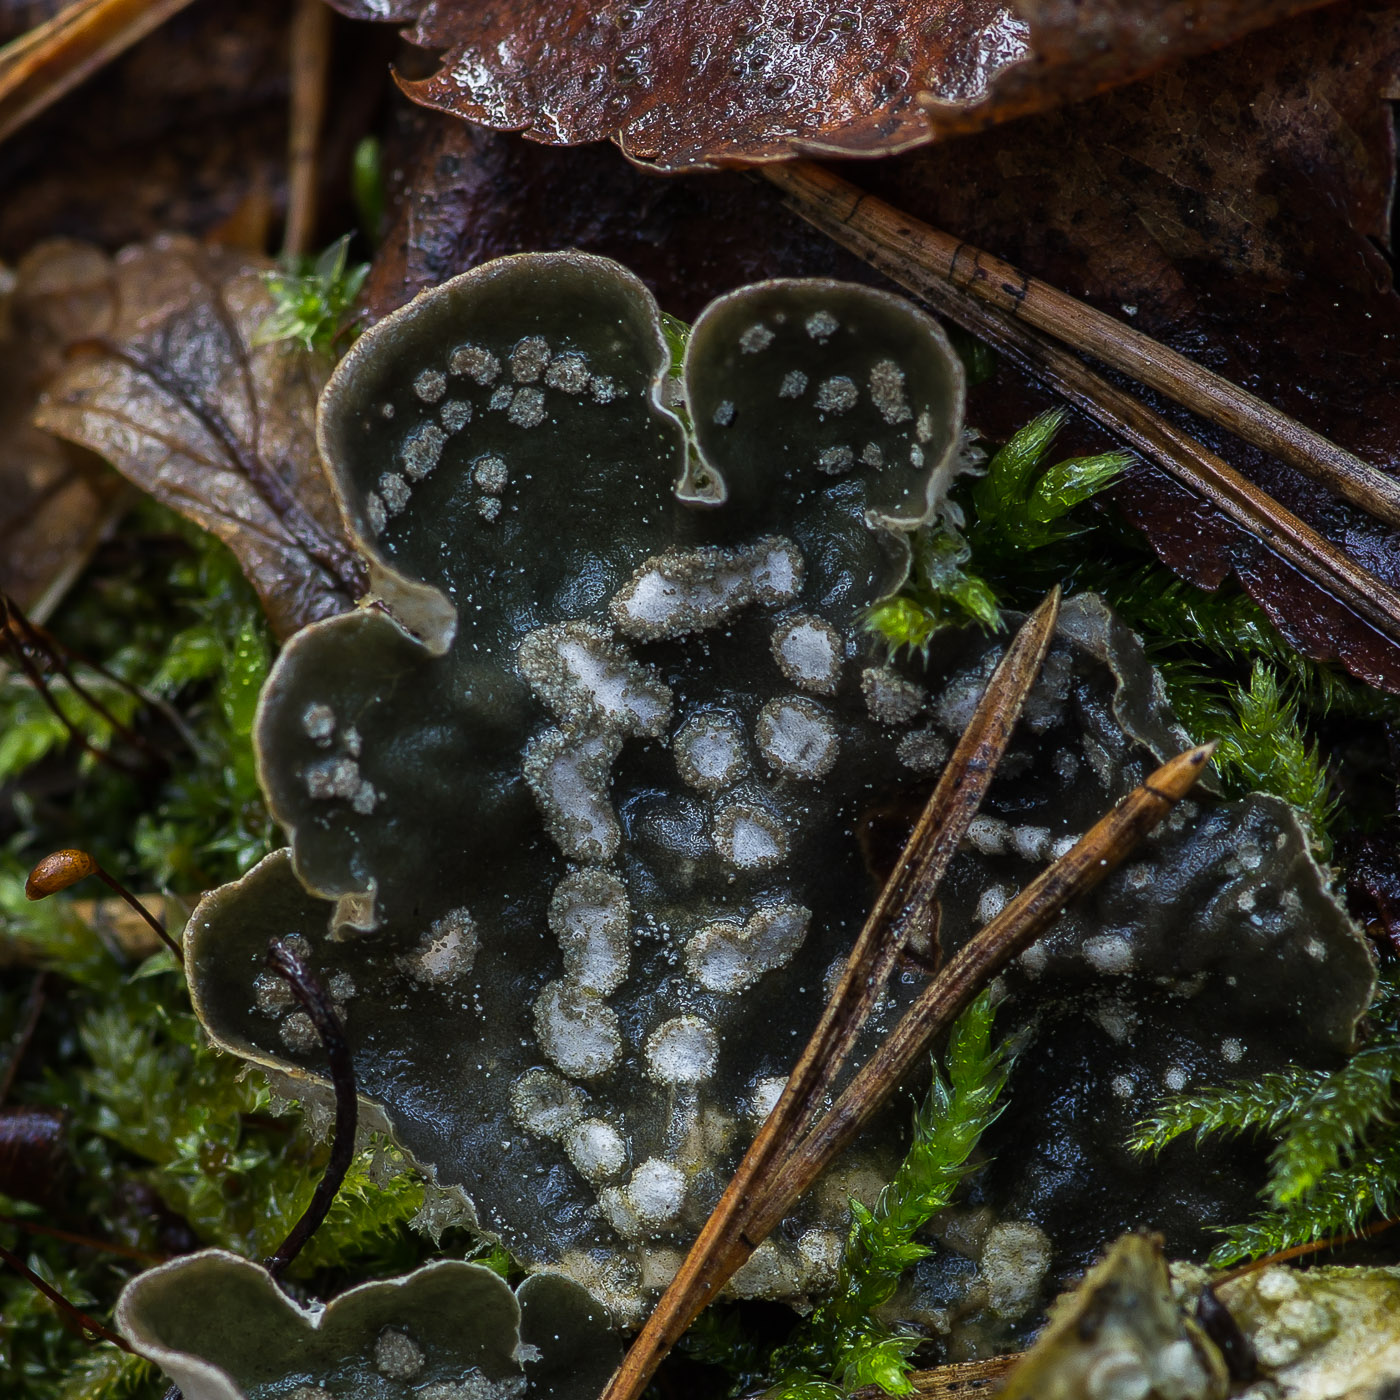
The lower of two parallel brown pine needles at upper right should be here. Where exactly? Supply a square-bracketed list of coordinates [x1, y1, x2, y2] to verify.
[763, 161, 1400, 643]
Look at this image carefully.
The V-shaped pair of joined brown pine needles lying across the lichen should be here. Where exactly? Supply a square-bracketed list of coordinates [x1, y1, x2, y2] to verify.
[602, 588, 1215, 1400]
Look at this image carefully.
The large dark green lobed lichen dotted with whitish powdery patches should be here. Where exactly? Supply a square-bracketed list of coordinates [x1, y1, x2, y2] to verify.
[188, 253, 1371, 1315]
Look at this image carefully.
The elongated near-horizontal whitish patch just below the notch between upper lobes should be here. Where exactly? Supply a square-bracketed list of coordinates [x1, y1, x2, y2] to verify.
[609, 536, 804, 641]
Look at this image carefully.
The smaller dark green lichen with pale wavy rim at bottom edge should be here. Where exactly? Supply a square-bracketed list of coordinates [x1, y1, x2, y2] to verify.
[116, 1250, 620, 1400]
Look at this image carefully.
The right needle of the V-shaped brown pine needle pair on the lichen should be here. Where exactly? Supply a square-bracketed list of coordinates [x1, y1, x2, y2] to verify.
[602, 743, 1215, 1400]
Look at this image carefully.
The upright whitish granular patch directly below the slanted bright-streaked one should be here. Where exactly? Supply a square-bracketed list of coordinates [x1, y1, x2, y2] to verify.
[524, 729, 622, 864]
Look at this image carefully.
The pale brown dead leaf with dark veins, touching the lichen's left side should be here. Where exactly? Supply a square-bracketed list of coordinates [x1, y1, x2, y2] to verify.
[35, 237, 364, 637]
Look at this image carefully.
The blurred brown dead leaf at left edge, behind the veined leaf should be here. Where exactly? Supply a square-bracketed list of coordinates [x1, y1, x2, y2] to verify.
[0, 241, 122, 622]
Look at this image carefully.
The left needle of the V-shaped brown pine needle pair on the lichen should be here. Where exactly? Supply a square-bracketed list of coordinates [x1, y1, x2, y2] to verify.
[603, 588, 1060, 1400]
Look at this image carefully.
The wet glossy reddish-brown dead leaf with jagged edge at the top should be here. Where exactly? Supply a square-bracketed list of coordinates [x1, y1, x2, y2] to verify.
[324, 0, 1317, 171]
